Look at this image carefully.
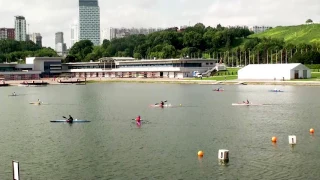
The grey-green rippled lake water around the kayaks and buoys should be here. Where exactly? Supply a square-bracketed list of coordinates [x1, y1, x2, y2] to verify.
[0, 83, 320, 180]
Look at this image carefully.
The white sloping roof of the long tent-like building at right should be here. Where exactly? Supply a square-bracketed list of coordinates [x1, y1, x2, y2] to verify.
[239, 63, 309, 71]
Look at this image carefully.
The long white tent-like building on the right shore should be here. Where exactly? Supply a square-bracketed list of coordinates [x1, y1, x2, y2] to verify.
[238, 63, 311, 80]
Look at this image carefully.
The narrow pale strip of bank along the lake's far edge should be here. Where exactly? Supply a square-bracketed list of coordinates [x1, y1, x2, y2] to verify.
[1, 78, 320, 87]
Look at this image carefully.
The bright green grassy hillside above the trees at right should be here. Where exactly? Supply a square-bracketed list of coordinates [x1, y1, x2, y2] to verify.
[249, 24, 320, 44]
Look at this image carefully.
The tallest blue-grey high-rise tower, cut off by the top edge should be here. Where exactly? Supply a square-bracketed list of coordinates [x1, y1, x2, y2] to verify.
[79, 0, 100, 45]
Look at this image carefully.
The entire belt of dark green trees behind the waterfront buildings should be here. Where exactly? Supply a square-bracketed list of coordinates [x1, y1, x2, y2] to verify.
[0, 23, 320, 66]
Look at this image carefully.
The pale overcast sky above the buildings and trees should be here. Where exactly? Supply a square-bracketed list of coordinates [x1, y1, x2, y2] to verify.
[0, 0, 320, 48]
